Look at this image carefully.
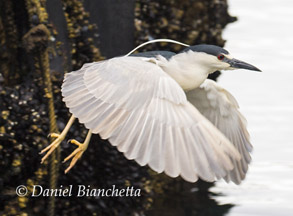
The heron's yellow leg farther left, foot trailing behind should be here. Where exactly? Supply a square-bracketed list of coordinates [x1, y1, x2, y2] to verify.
[40, 115, 75, 163]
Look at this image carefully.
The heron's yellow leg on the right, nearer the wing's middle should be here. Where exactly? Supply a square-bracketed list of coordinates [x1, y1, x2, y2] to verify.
[63, 130, 92, 173]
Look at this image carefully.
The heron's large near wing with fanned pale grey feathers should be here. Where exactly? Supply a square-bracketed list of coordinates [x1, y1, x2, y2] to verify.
[62, 57, 240, 182]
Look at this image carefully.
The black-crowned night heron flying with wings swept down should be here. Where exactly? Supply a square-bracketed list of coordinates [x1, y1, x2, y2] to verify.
[41, 39, 260, 184]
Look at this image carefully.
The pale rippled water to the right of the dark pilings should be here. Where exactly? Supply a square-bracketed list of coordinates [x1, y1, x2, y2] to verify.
[210, 0, 293, 216]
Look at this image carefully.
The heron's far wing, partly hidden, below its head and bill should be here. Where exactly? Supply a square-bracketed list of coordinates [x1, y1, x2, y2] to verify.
[186, 80, 252, 184]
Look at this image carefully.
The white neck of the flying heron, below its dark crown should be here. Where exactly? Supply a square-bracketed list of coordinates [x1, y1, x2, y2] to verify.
[159, 53, 213, 91]
